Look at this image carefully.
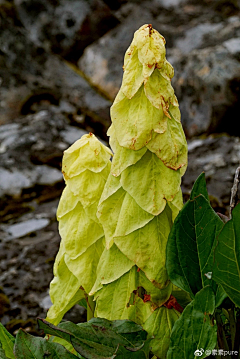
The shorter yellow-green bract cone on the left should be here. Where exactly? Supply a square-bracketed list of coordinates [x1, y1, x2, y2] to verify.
[46, 134, 112, 325]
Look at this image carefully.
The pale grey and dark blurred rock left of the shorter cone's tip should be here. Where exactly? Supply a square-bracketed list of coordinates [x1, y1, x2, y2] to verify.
[0, 107, 87, 198]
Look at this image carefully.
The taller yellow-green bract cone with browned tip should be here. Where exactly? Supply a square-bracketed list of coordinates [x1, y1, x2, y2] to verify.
[91, 25, 187, 359]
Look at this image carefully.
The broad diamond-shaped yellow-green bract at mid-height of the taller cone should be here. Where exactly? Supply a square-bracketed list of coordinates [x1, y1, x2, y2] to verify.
[120, 151, 181, 216]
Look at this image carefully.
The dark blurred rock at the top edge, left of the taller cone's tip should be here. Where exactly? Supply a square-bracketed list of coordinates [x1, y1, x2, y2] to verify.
[14, 0, 118, 61]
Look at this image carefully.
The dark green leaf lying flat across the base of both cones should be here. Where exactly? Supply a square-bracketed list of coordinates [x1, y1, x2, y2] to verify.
[38, 318, 149, 359]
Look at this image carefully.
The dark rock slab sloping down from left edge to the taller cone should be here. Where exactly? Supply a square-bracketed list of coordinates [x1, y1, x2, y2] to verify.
[0, 12, 111, 131]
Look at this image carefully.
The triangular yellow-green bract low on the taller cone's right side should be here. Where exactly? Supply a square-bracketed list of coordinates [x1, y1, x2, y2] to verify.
[114, 207, 172, 288]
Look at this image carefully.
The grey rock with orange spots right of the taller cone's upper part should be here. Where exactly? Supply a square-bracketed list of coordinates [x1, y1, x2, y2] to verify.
[171, 45, 240, 137]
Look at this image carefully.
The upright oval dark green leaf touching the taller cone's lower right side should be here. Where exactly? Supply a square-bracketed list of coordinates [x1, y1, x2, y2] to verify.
[166, 195, 223, 297]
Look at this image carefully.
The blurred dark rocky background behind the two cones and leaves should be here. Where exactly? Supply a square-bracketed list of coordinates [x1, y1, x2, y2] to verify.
[0, 0, 240, 333]
